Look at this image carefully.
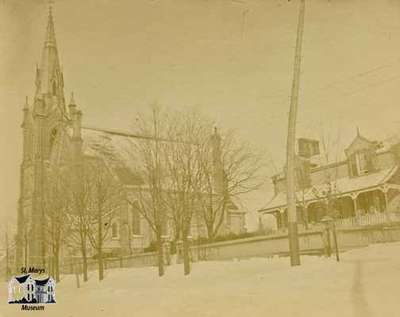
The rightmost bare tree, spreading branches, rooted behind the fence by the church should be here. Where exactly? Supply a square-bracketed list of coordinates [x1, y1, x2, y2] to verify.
[199, 129, 263, 240]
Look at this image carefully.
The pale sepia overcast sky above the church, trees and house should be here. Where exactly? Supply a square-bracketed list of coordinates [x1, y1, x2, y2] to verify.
[0, 0, 400, 228]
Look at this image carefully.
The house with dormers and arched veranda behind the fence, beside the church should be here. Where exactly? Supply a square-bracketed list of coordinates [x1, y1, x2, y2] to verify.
[258, 132, 400, 230]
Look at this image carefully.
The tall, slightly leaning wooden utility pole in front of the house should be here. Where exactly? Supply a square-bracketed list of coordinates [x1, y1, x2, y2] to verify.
[286, 0, 305, 266]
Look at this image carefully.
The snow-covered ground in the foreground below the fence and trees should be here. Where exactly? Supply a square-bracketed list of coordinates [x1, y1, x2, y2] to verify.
[0, 243, 400, 317]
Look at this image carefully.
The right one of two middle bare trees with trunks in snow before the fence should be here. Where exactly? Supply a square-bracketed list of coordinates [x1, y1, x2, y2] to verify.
[162, 112, 209, 275]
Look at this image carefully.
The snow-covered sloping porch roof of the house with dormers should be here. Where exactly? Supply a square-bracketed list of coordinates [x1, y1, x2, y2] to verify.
[259, 166, 398, 213]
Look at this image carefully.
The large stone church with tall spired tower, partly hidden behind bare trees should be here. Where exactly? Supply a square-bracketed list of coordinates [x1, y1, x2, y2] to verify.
[16, 7, 245, 268]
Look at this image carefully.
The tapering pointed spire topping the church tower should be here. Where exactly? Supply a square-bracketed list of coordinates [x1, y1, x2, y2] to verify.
[36, 4, 64, 100]
